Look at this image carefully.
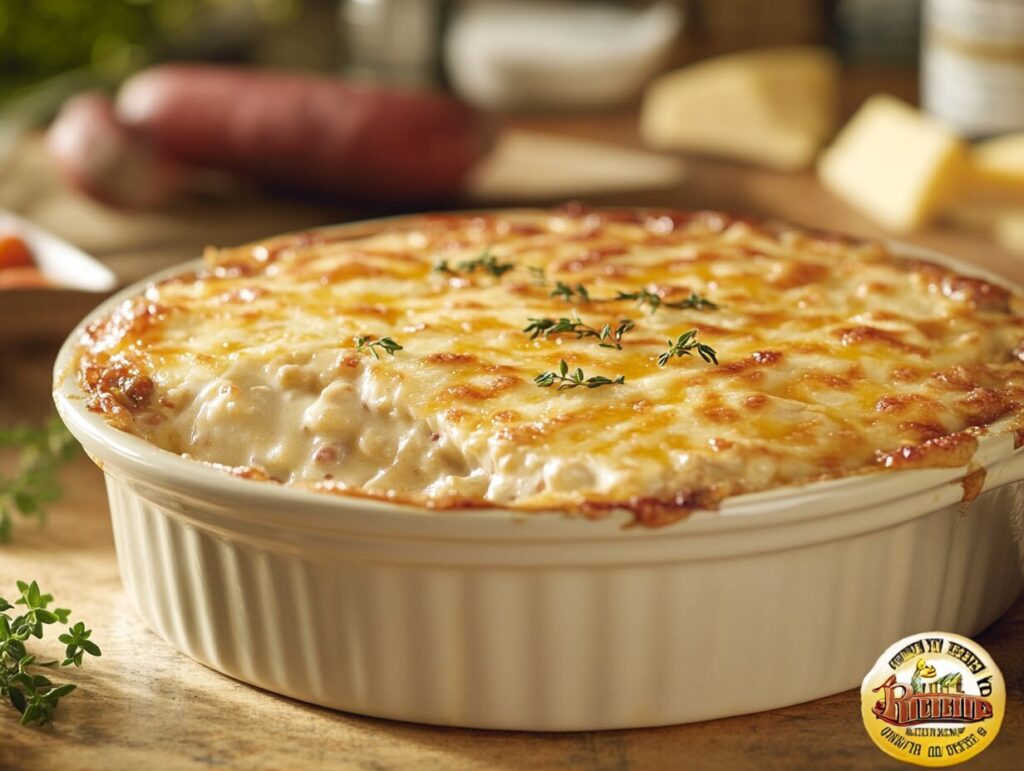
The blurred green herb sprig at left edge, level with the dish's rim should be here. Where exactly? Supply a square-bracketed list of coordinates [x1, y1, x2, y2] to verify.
[0, 416, 78, 544]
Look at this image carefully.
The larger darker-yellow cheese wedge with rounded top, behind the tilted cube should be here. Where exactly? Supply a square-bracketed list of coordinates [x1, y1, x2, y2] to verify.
[640, 46, 839, 170]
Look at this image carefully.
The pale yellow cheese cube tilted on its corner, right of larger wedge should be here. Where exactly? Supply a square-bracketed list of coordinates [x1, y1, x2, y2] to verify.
[818, 94, 967, 232]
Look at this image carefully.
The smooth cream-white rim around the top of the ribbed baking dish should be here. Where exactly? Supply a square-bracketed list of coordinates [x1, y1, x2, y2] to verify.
[53, 207, 1024, 541]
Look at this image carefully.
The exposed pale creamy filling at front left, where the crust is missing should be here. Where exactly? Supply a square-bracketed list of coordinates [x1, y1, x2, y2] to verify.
[147, 353, 488, 498]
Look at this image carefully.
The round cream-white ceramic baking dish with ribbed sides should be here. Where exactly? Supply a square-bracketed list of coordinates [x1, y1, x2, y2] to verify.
[55, 225, 1024, 730]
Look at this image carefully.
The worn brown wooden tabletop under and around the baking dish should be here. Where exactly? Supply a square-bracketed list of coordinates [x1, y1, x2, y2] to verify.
[0, 108, 1024, 771]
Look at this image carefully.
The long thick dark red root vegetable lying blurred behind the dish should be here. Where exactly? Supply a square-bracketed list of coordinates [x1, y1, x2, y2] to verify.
[117, 65, 490, 201]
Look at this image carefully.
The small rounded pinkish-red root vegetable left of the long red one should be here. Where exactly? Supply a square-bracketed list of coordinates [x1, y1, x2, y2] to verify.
[47, 93, 183, 208]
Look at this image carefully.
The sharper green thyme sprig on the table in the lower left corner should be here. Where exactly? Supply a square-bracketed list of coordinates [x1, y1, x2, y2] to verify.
[0, 581, 101, 726]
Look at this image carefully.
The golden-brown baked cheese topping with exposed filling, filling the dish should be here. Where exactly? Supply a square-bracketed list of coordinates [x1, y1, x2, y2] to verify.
[78, 207, 1024, 523]
